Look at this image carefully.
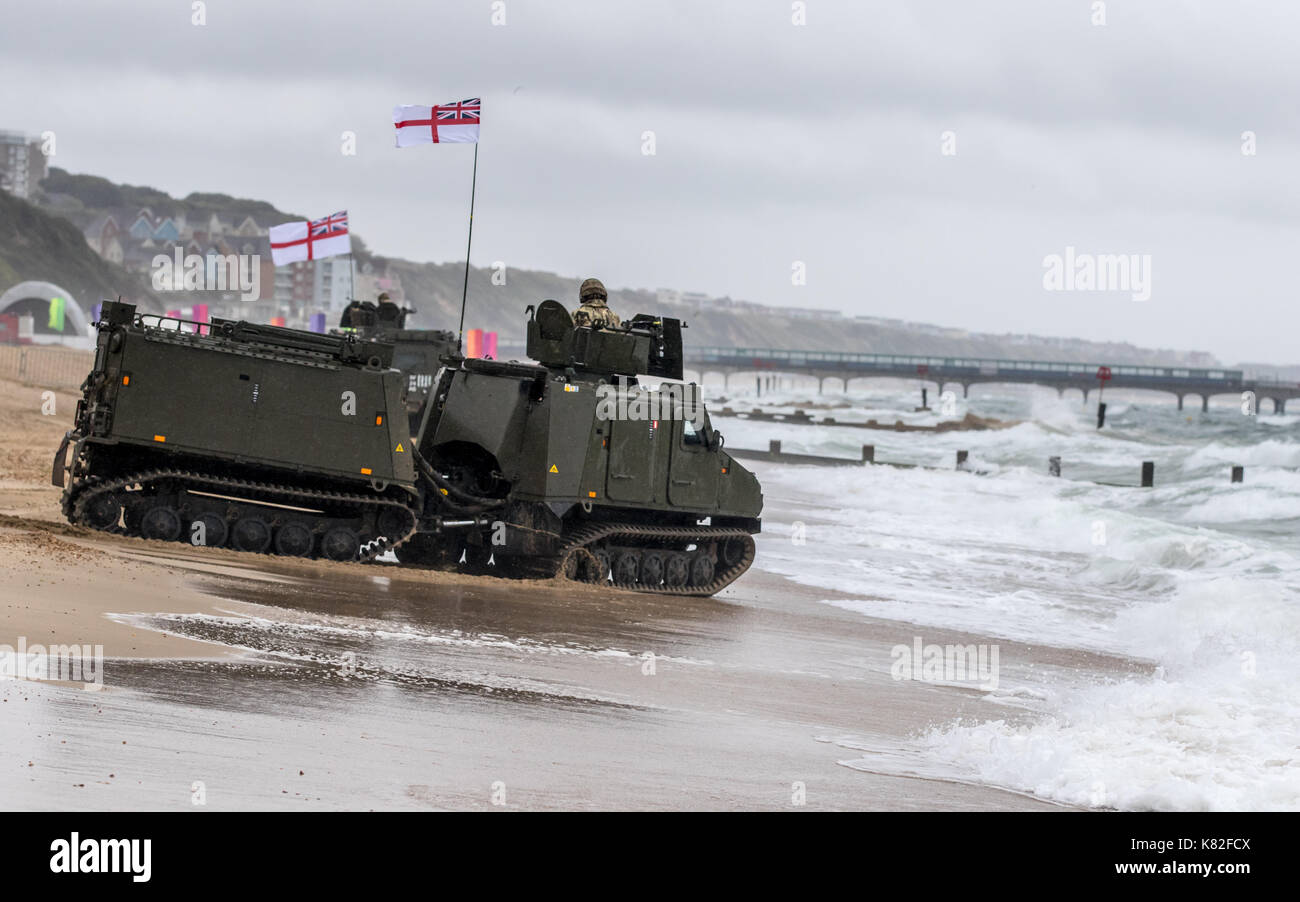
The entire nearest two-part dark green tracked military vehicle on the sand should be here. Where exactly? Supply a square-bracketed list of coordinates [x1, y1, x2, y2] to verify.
[53, 300, 762, 595]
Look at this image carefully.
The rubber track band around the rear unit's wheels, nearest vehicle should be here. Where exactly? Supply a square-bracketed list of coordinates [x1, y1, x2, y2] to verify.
[64, 469, 416, 561]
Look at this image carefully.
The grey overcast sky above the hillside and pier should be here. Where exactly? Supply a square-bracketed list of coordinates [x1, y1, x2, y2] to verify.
[0, 0, 1300, 363]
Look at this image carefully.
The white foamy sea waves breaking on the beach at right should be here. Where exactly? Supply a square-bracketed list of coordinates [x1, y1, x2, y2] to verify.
[748, 382, 1300, 810]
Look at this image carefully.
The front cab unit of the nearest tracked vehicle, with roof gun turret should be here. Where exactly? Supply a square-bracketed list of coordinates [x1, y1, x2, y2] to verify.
[397, 300, 763, 595]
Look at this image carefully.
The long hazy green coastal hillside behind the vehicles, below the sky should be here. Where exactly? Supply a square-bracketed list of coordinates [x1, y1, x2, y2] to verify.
[0, 168, 1227, 365]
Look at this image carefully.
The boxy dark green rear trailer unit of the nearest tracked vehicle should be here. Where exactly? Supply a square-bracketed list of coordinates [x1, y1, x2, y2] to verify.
[53, 308, 420, 560]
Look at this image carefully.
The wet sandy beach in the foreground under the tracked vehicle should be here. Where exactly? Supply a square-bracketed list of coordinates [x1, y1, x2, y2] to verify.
[0, 376, 1127, 810]
